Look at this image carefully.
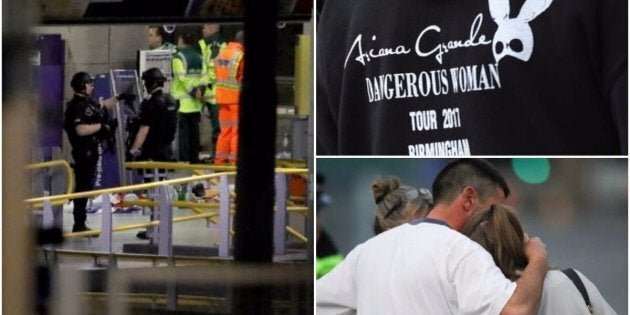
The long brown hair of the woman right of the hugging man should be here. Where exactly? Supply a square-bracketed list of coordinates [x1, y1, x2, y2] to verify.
[462, 205, 527, 280]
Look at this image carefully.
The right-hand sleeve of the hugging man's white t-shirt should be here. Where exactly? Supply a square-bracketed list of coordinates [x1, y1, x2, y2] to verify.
[452, 247, 516, 315]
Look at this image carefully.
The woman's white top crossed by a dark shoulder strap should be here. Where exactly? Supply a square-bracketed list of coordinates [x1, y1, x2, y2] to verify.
[538, 270, 617, 315]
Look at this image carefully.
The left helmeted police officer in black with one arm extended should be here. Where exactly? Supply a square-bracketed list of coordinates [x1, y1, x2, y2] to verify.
[64, 72, 118, 232]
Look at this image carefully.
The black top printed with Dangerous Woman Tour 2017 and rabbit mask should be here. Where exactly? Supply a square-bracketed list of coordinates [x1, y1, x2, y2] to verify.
[316, 0, 628, 156]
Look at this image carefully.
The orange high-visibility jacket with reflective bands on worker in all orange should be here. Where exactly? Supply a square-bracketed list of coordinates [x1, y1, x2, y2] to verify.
[214, 42, 244, 104]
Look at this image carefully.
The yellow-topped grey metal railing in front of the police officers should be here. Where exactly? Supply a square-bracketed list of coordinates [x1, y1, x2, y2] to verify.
[25, 162, 308, 257]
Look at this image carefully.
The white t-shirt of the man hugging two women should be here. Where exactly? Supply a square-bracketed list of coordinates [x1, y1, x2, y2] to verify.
[316, 222, 516, 315]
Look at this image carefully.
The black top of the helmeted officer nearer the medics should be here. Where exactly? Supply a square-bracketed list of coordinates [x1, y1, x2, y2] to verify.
[139, 90, 178, 161]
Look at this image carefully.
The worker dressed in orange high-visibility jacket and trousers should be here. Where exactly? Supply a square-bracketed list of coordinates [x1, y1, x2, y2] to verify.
[214, 31, 244, 164]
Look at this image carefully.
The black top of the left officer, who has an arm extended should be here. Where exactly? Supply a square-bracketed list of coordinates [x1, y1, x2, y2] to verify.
[63, 94, 104, 151]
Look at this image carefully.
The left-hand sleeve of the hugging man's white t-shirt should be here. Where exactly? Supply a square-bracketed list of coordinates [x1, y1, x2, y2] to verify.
[315, 245, 361, 315]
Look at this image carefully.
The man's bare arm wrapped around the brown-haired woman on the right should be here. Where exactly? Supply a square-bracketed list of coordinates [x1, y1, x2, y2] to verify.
[501, 237, 548, 315]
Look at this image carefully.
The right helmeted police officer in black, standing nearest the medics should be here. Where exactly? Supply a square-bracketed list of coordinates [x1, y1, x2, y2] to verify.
[129, 68, 179, 239]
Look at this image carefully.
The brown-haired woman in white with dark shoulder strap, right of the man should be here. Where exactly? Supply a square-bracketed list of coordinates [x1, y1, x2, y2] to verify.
[462, 205, 617, 315]
